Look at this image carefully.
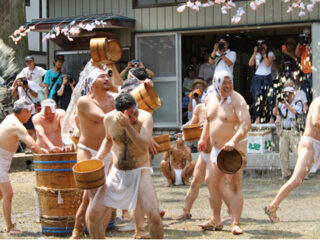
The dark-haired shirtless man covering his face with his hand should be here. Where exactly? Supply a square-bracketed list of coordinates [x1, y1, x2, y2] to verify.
[88, 93, 163, 239]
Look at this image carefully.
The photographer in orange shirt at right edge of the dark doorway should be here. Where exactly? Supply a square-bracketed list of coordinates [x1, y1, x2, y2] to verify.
[295, 28, 312, 105]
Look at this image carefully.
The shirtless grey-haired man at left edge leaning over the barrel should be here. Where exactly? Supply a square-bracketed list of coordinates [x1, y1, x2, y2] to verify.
[0, 99, 42, 234]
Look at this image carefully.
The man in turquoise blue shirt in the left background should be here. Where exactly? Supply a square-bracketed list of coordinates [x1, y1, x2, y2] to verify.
[43, 55, 64, 99]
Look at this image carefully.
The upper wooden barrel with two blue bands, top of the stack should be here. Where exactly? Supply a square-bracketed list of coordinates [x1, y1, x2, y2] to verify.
[33, 152, 77, 188]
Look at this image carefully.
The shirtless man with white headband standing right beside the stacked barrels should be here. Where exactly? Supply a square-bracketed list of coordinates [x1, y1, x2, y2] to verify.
[71, 68, 115, 239]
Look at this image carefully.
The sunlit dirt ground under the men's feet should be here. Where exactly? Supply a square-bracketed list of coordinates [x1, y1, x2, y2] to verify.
[0, 172, 320, 239]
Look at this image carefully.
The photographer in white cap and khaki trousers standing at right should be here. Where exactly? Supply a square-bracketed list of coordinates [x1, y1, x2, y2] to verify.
[273, 87, 303, 180]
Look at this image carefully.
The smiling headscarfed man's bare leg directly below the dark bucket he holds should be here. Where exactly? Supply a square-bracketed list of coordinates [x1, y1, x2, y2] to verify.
[227, 170, 243, 234]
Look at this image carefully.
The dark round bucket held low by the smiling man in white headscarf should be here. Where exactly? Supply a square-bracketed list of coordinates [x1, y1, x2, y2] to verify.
[217, 149, 242, 174]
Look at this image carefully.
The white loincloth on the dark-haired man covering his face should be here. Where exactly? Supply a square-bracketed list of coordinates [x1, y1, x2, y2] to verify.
[104, 166, 152, 210]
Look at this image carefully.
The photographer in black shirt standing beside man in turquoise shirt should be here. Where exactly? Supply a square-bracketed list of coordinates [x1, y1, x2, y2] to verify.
[56, 73, 76, 110]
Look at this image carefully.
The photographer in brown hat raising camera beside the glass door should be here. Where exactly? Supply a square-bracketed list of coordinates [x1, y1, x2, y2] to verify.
[188, 79, 207, 120]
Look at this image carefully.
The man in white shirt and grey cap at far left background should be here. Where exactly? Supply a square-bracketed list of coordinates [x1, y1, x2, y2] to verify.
[17, 56, 46, 86]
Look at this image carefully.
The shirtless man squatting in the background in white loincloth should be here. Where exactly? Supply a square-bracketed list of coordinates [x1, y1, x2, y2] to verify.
[160, 133, 196, 187]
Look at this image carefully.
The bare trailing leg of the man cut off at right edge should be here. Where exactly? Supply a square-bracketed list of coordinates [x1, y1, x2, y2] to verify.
[265, 141, 314, 222]
